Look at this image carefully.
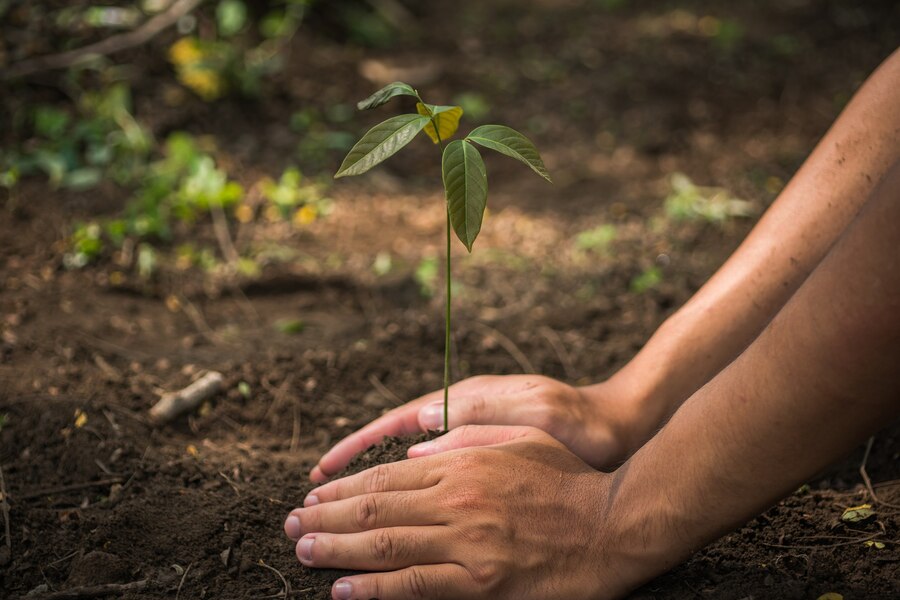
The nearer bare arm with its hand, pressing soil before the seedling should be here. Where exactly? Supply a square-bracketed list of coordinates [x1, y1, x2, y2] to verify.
[285, 165, 900, 600]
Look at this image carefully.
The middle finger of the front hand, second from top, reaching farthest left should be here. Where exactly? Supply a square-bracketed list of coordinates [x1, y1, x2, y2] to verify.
[284, 491, 435, 540]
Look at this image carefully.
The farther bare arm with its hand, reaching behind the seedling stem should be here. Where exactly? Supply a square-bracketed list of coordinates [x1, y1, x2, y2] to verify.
[311, 50, 900, 482]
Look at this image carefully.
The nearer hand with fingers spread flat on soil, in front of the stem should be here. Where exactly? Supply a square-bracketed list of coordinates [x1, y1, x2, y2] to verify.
[285, 426, 627, 600]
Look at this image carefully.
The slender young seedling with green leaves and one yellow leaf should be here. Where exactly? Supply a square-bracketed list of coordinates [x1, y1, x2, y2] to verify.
[335, 81, 550, 431]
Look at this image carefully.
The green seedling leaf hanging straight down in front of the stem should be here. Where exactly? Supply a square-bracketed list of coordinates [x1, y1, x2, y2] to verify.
[441, 140, 487, 252]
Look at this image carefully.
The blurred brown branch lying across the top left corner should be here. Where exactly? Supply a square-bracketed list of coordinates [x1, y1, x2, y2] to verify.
[0, 0, 203, 80]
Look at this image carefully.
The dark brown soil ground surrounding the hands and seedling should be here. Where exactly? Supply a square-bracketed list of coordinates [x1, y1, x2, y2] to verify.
[0, 1, 900, 599]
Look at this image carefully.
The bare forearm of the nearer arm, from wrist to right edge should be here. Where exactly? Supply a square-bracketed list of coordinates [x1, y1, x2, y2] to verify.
[612, 167, 900, 583]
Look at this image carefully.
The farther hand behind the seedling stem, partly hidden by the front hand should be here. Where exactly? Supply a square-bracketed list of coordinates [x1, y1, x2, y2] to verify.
[310, 375, 639, 483]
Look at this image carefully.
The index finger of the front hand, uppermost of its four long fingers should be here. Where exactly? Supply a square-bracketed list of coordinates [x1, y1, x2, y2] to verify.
[303, 459, 442, 507]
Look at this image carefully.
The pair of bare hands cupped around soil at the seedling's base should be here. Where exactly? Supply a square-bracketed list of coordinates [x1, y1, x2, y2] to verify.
[285, 376, 652, 600]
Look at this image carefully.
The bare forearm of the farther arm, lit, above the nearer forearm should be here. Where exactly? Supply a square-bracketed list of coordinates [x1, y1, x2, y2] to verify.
[596, 50, 900, 432]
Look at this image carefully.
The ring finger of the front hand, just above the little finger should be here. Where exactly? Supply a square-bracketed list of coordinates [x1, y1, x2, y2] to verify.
[296, 526, 448, 572]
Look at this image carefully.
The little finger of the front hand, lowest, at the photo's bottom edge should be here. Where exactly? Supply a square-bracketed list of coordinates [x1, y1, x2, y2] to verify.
[331, 564, 475, 600]
